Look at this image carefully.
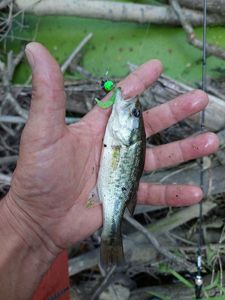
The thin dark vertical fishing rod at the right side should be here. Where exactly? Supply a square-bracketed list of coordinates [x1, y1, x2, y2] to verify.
[195, 0, 207, 299]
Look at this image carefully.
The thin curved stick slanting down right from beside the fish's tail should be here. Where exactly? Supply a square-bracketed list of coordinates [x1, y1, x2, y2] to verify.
[124, 214, 194, 269]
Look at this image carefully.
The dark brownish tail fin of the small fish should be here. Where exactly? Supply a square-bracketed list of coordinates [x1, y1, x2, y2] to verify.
[100, 236, 124, 271]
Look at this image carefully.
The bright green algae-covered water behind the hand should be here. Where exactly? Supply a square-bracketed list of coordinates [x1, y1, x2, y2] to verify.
[5, 16, 225, 84]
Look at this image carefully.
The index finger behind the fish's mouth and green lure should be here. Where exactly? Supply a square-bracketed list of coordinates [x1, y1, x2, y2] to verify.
[83, 60, 162, 130]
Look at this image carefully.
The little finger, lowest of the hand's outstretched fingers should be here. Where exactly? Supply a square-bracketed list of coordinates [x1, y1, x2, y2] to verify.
[138, 182, 203, 206]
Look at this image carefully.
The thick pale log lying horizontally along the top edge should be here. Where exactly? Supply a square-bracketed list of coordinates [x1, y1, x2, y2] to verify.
[14, 0, 225, 25]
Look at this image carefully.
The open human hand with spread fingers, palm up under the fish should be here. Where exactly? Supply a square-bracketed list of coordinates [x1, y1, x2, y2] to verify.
[4, 43, 218, 255]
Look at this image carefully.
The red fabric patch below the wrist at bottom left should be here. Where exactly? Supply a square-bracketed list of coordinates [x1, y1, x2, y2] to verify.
[32, 251, 70, 300]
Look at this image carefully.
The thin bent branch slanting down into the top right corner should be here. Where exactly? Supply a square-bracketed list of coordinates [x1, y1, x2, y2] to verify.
[170, 0, 225, 59]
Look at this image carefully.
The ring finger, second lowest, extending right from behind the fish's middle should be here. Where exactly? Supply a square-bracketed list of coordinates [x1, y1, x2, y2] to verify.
[145, 133, 219, 172]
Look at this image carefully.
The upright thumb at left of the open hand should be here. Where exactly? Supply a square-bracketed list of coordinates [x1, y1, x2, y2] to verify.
[24, 42, 66, 144]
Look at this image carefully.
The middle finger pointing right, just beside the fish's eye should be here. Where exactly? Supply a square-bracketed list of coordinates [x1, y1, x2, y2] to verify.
[143, 90, 208, 137]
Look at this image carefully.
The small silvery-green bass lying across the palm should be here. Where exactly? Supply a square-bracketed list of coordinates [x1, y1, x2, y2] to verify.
[97, 87, 146, 270]
